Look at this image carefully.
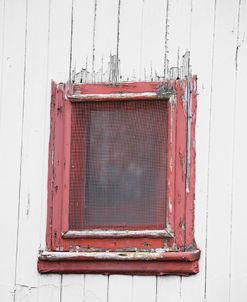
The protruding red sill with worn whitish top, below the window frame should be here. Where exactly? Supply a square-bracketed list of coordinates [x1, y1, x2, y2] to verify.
[38, 249, 200, 276]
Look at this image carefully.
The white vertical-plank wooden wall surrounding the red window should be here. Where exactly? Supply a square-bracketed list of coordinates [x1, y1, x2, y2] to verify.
[0, 0, 247, 302]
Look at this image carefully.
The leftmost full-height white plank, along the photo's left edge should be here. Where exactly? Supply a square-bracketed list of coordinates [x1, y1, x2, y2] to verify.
[0, 1, 26, 302]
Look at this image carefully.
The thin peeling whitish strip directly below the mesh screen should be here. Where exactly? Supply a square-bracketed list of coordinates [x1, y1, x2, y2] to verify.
[62, 230, 173, 238]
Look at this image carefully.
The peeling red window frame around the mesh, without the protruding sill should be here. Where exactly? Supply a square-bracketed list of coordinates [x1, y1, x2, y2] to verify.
[44, 78, 199, 271]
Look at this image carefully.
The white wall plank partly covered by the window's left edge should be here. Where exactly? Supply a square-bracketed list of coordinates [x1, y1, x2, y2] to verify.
[38, 0, 72, 302]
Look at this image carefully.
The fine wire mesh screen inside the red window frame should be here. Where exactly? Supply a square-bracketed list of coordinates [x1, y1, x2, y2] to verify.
[69, 100, 167, 230]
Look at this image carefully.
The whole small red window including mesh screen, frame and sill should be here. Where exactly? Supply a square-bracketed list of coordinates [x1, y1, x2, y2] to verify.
[38, 77, 200, 275]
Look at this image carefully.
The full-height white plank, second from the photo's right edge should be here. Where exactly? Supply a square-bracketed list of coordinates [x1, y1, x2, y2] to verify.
[206, 1, 238, 302]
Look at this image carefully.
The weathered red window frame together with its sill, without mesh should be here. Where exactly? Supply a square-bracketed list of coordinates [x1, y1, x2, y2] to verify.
[38, 76, 200, 275]
